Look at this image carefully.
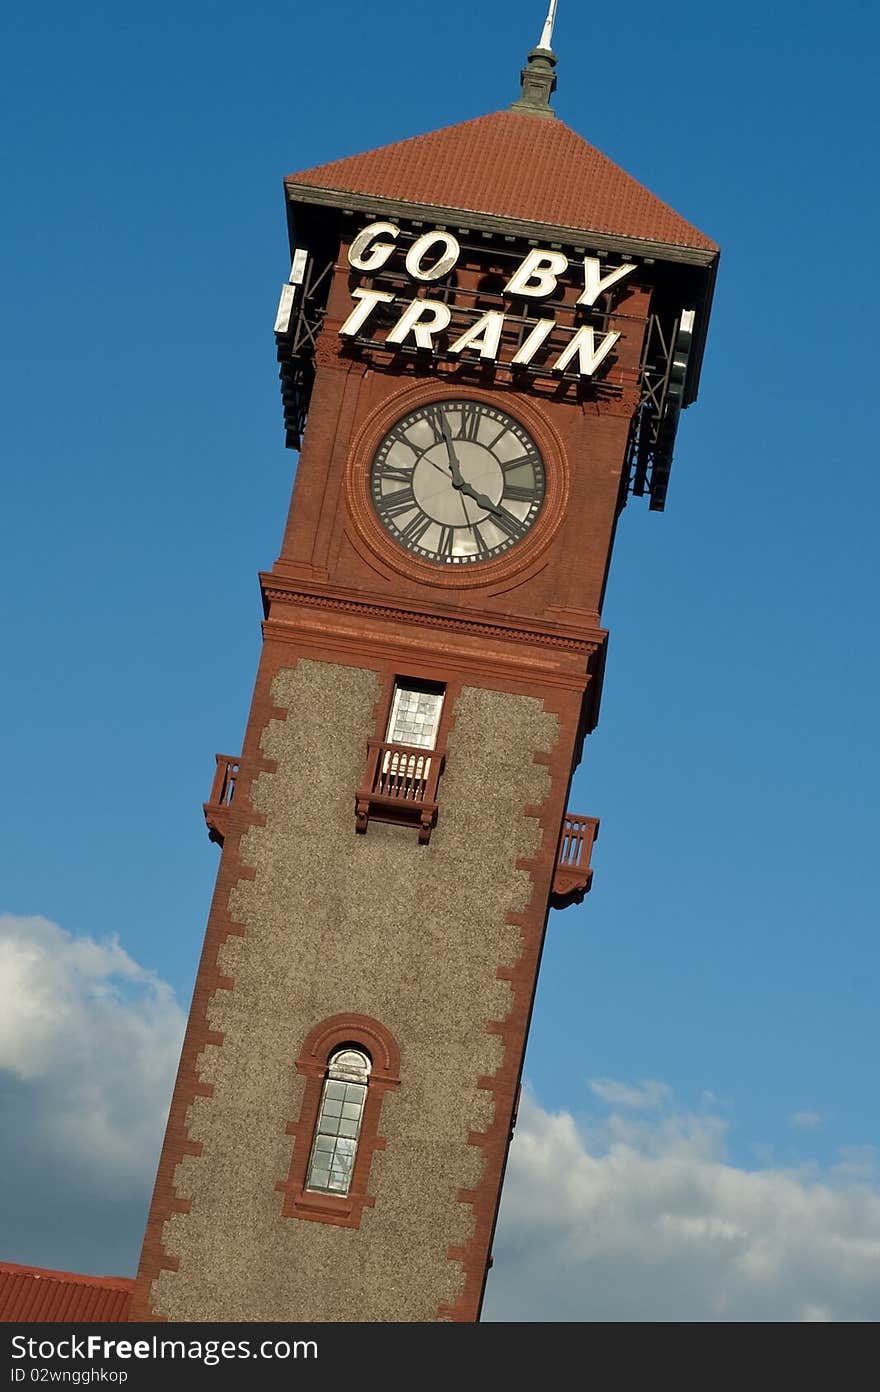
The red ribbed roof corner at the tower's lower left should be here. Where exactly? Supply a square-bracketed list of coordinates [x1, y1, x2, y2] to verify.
[0, 1261, 134, 1324]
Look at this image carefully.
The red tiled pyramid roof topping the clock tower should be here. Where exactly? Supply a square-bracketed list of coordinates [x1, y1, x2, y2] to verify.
[288, 111, 717, 251]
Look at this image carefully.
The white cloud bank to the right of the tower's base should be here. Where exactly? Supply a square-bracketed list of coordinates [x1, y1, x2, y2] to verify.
[485, 1089, 880, 1321]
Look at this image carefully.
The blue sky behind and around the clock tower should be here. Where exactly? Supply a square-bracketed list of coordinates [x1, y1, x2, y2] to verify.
[0, 0, 880, 1318]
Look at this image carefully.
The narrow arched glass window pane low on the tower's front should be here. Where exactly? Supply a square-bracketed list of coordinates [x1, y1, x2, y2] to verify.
[305, 1048, 372, 1196]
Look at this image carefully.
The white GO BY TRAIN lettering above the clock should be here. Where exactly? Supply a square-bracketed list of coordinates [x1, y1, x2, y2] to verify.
[340, 223, 635, 377]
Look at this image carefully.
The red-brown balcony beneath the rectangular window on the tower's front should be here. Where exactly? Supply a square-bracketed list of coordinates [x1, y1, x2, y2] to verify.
[355, 739, 446, 846]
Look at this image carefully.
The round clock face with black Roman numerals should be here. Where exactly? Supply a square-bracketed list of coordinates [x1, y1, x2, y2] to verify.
[370, 401, 544, 565]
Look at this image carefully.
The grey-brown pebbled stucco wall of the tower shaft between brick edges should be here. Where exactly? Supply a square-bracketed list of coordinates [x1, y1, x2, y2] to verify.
[153, 660, 557, 1321]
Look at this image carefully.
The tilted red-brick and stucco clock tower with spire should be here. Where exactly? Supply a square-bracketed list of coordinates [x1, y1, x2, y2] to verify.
[131, 17, 717, 1321]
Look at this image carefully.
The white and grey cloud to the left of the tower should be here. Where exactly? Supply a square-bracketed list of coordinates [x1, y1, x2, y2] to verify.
[0, 913, 184, 1270]
